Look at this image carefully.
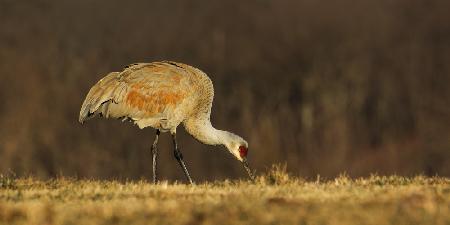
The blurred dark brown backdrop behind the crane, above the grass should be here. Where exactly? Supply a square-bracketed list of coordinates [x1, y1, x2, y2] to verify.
[0, 0, 450, 181]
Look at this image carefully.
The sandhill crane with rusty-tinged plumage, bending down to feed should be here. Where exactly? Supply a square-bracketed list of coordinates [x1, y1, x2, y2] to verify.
[79, 61, 254, 184]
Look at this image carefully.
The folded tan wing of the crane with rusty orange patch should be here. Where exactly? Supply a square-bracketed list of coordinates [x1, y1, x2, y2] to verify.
[79, 62, 192, 127]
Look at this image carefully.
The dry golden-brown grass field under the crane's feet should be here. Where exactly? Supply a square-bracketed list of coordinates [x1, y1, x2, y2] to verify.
[0, 166, 450, 225]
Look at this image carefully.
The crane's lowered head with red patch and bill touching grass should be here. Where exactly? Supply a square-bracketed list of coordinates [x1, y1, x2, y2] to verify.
[224, 132, 255, 180]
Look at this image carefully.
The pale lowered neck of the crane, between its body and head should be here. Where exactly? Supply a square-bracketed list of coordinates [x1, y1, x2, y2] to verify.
[184, 118, 229, 145]
